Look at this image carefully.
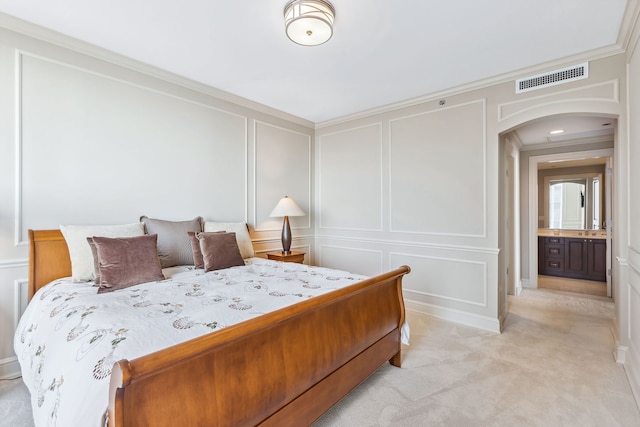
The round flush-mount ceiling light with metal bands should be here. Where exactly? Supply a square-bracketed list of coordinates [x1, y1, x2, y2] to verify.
[284, 0, 335, 46]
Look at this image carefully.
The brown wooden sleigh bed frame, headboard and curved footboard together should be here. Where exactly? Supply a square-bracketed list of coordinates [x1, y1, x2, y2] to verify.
[29, 230, 410, 427]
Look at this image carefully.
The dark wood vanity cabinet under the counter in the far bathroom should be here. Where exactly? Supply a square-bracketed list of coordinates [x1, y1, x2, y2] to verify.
[538, 236, 607, 282]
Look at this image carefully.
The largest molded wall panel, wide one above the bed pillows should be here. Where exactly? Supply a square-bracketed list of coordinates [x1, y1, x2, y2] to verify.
[15, 52, 247, 245]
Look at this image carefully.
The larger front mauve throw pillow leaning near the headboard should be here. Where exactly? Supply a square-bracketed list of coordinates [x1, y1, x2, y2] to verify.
[93, 234, 164, 293]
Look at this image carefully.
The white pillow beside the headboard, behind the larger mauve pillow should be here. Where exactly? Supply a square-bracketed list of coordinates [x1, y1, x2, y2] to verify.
[60, 222, 144, 282]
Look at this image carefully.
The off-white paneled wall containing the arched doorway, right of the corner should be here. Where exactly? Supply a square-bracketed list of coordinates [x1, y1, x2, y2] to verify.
[315, 55, 626, 331]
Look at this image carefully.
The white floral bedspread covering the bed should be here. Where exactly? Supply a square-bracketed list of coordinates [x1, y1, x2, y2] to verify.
[14, 258, 406, 427]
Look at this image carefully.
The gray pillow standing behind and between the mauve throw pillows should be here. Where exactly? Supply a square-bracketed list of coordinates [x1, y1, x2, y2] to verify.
[140, 215, 203, 268]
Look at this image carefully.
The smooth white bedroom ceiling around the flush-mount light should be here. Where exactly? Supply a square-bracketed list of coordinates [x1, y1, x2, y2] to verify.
[0, 0, 634, 123]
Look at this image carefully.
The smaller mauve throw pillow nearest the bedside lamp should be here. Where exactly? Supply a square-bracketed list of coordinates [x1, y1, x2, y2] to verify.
[196, 233, 245, 271]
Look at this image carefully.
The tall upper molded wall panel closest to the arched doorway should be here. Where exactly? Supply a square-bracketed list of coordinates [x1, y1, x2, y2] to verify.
[389, 99, 487, 238]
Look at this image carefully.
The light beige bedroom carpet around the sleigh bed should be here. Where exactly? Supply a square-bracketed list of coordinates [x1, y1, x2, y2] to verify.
[0, 289, 640, 427]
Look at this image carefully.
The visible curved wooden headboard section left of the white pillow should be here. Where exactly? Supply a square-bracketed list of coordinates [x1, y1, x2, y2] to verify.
[29, 230, 71, 300]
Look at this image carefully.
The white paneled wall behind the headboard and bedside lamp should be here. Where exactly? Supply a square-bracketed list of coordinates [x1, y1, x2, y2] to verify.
[0, 24, 313, 378]
